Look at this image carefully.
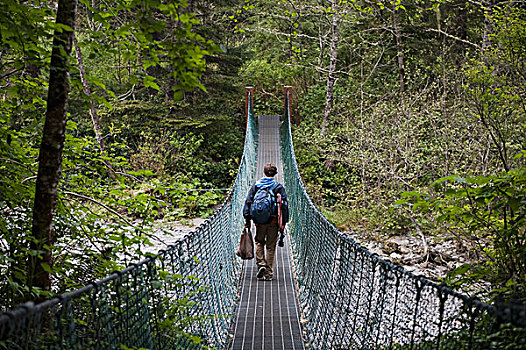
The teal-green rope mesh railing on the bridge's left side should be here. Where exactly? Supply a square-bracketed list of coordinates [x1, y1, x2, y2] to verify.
[0, 91, 257, 350]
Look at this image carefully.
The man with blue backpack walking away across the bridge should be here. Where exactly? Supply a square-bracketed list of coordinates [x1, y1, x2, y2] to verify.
[243, 163, 289, 281]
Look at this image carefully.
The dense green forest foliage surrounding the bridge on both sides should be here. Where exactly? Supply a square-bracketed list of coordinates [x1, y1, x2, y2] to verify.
[0, 0, 526, 307]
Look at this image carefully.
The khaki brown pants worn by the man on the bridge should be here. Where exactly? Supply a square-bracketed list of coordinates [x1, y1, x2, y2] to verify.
[255, 220, 278, 277]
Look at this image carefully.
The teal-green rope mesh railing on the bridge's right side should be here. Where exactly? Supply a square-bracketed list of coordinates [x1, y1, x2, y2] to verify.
[281, 90, 526, 349]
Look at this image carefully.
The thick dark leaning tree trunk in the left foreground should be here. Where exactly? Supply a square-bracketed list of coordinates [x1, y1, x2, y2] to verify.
[28, 0, 77, 300]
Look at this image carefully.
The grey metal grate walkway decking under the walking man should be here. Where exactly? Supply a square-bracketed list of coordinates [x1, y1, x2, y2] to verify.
[230, 116, 305, 350]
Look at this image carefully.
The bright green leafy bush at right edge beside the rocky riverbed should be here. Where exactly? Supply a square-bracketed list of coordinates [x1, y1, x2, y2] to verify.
[397, 161, 526, 301]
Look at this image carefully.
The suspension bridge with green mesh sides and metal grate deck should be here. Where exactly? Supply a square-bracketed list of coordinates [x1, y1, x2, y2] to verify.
[0, 87, 526, 350]
